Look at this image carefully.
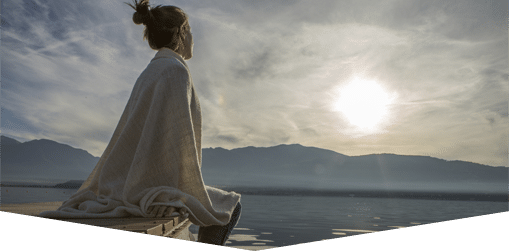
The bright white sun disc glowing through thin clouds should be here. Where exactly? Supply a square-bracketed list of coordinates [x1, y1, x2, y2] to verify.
[335, 78, 391, 130]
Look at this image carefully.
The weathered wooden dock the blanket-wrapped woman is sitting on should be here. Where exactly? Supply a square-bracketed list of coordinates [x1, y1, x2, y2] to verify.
[0, 202, 195, 241]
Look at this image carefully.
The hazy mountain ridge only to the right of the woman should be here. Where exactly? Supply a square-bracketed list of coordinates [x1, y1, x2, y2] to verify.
[202, 144, 509, 193]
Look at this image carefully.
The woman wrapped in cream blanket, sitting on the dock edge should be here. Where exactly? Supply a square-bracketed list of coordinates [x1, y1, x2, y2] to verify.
[40, 0, 241, 245]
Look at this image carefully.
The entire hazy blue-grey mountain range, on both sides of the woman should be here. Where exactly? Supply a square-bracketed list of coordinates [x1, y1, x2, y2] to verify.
[0, 136, 509, 193]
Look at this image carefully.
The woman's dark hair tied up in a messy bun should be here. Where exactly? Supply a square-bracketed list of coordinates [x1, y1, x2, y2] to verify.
[125, 0, 189, 52]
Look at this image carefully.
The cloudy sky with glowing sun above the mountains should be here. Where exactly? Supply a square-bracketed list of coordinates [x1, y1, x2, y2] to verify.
[0, 0, 509, 167]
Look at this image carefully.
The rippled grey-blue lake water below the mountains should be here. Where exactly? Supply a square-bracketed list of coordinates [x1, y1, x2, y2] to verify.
[1, 187, 509, 249]
